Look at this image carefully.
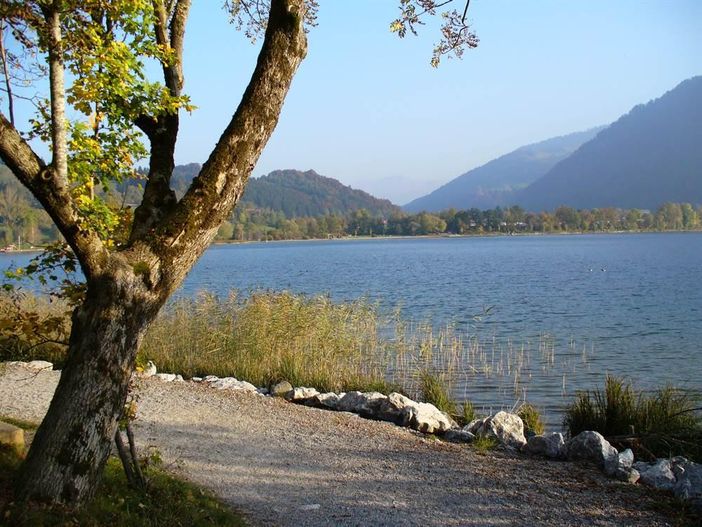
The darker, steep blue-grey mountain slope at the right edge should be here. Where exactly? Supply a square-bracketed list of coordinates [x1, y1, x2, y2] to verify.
[511, 76, 702, 211]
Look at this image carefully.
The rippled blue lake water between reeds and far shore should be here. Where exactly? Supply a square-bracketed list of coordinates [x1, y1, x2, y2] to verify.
[0, 233, 702, 427]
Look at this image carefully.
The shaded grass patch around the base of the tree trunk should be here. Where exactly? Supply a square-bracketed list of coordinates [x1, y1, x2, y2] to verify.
[0, 448, 245, 527]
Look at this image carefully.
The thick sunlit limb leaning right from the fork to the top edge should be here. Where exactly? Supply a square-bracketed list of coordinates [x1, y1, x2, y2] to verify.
[151, 0, 307, 292]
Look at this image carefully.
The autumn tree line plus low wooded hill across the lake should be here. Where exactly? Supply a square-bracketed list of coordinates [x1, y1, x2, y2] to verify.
[0, 160, 702, 247]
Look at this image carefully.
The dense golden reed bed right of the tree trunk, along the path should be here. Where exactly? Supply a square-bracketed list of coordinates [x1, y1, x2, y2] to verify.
[140, 292, 391, 391]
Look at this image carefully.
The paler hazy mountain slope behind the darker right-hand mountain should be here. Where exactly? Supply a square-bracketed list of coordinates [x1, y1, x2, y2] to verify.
[403, 127, 602, 212]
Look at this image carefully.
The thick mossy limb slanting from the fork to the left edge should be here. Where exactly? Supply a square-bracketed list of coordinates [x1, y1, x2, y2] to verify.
[0, 114, 108, 279]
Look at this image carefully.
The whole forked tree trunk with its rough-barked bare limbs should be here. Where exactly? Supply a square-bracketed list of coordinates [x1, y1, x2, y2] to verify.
[0, 0, 307, 504]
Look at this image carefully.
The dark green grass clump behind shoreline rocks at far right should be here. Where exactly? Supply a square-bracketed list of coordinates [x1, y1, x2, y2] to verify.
[564, 376, 702, 461]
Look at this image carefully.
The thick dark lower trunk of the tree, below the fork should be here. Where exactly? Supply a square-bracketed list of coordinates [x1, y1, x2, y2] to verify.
[16, 266, 161, 503]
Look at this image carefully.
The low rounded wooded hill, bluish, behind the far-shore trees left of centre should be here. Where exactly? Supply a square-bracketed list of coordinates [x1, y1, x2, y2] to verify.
[171, 163, 400, 218]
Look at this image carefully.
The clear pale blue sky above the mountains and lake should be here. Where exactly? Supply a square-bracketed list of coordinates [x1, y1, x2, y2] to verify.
[8, 0, 702, 204]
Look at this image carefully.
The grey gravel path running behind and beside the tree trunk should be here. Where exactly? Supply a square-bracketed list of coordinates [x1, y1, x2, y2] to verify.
[0, 365, 670, 527]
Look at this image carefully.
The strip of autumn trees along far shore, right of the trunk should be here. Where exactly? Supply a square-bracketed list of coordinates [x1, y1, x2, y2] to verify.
[217, 203, 702, 241]
